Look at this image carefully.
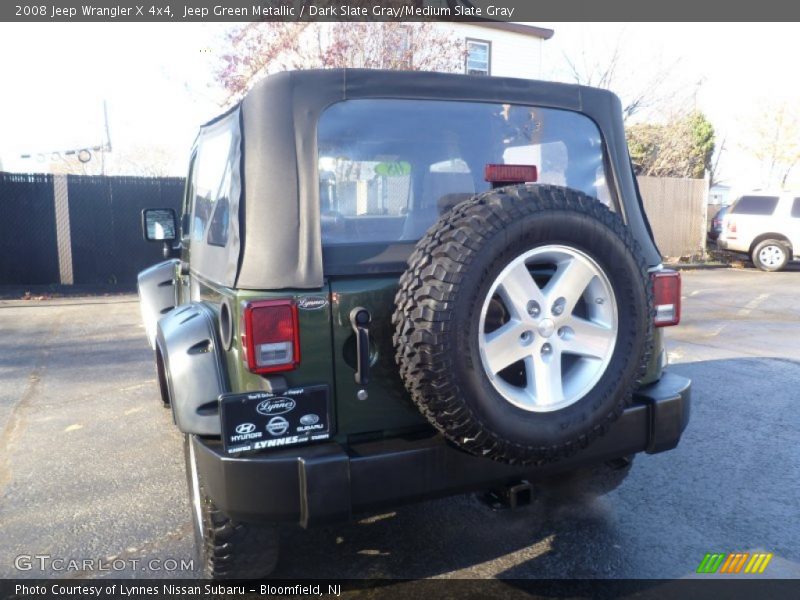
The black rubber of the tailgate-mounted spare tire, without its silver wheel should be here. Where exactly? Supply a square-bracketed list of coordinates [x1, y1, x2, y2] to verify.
[393, 185, 653, 464]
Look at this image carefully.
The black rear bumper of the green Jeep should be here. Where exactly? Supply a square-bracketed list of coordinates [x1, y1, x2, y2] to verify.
[192, 372, 691, 527]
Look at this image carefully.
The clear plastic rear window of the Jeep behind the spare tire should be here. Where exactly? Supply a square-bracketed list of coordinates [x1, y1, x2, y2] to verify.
[318, 99, 611, 246]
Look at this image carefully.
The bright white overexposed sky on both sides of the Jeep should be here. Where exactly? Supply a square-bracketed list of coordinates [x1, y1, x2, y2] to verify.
[0, 23, 800, 187]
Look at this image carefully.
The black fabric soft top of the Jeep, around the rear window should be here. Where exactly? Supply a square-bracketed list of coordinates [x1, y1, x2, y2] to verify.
[200, 69, 661, 289]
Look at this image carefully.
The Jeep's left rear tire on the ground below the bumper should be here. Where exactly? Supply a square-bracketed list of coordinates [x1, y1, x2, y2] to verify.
[183, 435, 279, 579]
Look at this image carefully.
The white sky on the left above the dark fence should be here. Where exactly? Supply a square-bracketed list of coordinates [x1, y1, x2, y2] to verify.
[0, 23, 223, 174]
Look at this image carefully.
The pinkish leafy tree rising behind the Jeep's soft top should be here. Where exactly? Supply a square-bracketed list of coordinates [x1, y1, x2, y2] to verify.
[216, 22, 465, 104]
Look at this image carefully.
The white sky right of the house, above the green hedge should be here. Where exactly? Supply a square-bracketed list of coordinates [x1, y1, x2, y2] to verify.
[543, 23, 800, 189]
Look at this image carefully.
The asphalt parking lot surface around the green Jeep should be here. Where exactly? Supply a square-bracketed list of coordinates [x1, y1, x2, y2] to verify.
[0, 268, 800, 578]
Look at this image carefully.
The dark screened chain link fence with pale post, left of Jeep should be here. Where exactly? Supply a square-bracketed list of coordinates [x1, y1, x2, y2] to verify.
[0, 173, 184, 288]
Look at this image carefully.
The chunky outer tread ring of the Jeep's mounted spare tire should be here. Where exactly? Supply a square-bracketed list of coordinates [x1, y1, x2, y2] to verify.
[392, 184, 654, 464]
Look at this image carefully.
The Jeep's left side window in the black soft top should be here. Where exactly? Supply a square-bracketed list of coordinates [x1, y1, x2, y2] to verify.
[191, 130, 232, 246]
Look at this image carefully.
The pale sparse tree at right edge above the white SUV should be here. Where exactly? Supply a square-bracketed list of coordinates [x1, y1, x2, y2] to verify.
[743, 102, 800, 188]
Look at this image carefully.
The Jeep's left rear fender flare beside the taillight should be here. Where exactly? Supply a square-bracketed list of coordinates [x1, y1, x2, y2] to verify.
[156, 302, 229, 435]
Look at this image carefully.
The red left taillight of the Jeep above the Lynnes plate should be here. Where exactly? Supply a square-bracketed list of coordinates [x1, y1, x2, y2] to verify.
[242, 300, 300, 373]
